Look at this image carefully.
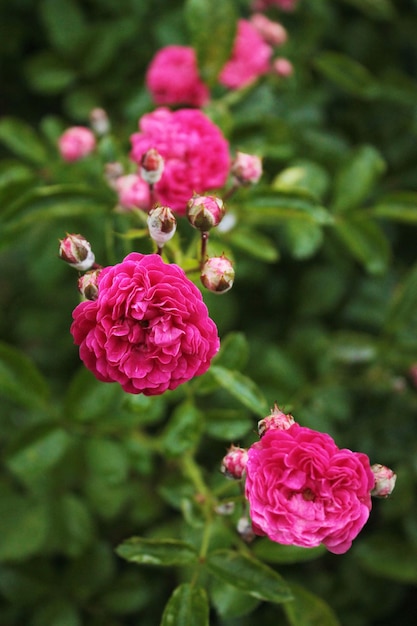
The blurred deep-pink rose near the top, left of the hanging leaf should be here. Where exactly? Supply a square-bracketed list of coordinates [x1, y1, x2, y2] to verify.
[146, 46, 210, 107]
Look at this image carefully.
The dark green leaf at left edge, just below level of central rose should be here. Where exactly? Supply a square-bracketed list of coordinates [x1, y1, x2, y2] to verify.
[0, 343, 49, 409]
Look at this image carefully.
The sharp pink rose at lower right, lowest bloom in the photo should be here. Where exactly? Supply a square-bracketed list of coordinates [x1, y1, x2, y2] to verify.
[246, 424, 375, 554]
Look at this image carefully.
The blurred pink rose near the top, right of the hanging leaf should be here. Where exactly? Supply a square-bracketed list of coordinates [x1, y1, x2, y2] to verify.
[219, 20, 272, 89]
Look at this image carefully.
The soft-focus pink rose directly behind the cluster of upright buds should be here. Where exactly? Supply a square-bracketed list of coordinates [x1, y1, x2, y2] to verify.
[130, 108, 230, 215]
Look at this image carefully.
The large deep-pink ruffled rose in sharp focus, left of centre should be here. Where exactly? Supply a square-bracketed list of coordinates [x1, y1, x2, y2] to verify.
[71, 252, 219, 396]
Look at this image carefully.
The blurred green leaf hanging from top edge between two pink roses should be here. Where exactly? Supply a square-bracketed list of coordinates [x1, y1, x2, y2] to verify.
[185, 0, 237, 86]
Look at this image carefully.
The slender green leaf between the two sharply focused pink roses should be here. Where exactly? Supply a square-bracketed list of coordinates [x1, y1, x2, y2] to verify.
[210, 365, 268, 417]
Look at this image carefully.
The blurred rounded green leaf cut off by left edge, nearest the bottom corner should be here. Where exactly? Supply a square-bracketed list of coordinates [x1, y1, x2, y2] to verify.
[0, 493, 48, 561]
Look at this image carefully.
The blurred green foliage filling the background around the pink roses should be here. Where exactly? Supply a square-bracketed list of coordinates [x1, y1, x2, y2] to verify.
[0, 0, 417, 626]
